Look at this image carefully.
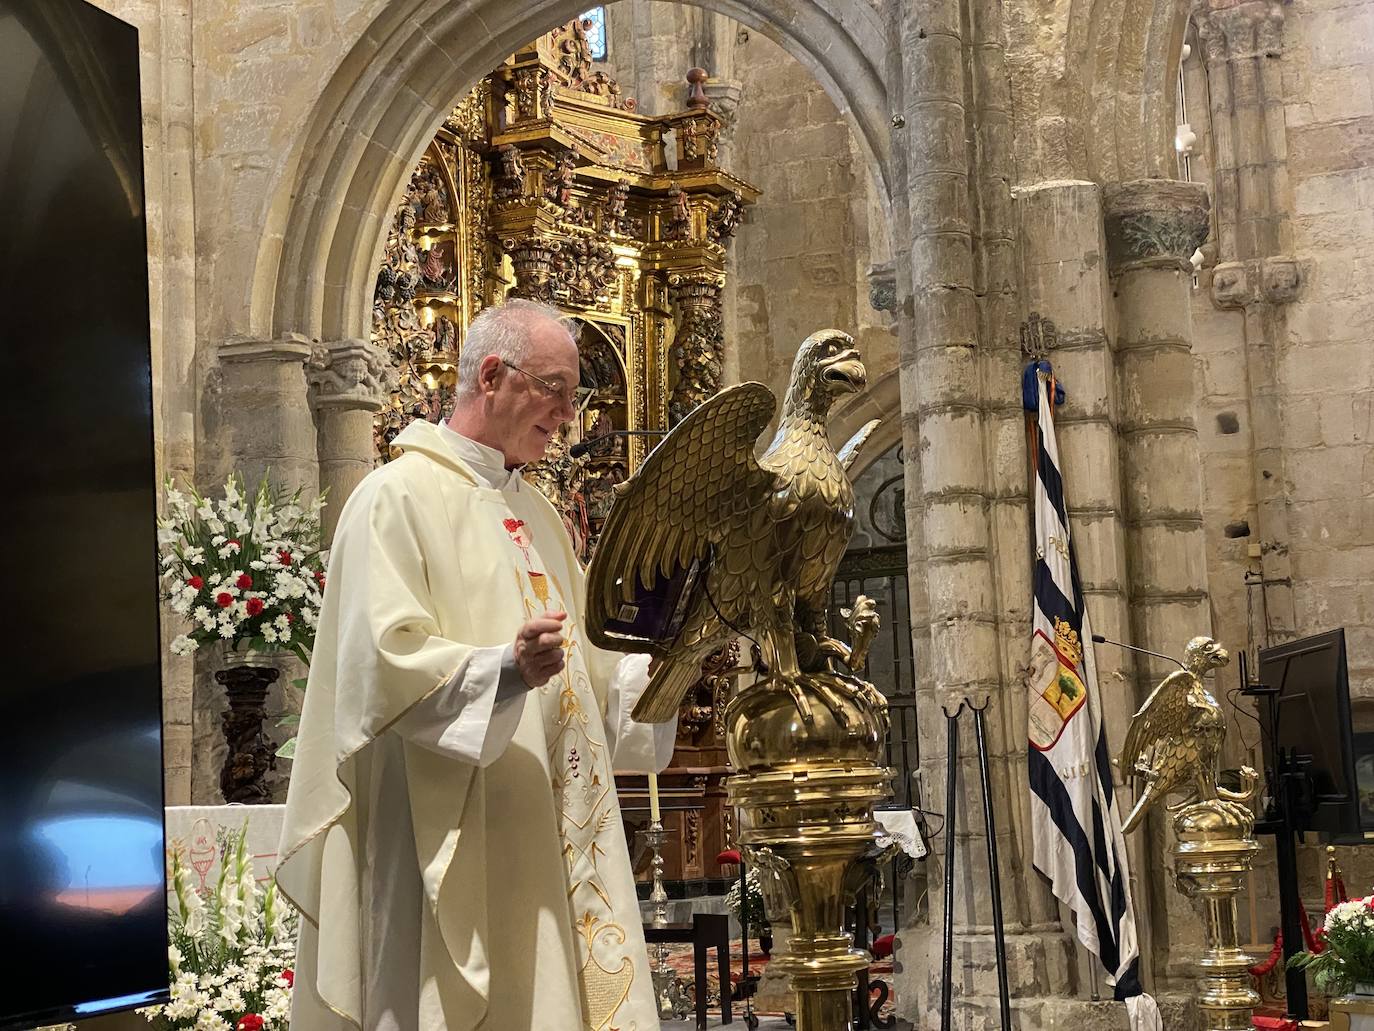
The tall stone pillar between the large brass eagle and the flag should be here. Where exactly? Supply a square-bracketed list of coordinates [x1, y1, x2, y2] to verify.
[894, 0, 1088, 1011]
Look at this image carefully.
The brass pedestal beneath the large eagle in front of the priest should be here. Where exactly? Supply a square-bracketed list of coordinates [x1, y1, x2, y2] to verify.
[725, 674, 892, 1031]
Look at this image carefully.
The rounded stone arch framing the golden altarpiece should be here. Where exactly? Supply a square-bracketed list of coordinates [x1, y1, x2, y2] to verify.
[252, 0, 890, 347]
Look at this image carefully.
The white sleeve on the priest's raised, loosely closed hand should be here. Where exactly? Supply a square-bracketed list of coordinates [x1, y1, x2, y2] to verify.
[394, 645, 529, 766]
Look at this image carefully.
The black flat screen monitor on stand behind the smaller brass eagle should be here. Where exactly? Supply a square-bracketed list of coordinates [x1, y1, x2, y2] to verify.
[1260, 630, 1360, 834]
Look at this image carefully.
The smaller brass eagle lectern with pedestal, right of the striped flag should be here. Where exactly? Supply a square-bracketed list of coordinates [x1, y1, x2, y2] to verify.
[1121, 638, 1260, 1031]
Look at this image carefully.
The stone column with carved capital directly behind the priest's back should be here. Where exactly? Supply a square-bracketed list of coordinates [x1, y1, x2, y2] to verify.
[309, 340, 394, 540]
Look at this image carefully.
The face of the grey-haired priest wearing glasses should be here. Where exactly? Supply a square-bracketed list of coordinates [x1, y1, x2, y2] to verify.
[489, 320, 578, 466]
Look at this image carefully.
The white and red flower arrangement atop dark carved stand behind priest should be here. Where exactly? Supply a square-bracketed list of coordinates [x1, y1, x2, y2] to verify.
[158, 476, 327, 664]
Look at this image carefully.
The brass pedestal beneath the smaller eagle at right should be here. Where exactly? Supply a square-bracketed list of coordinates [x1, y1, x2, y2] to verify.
[1173, 801, 1260, 1031]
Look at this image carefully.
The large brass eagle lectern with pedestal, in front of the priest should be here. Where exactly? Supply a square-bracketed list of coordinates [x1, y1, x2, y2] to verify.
[587, 330, 892, 1031]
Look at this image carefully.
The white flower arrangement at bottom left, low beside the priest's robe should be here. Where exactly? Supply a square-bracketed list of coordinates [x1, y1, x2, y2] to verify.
[140, 825, 297, 1031]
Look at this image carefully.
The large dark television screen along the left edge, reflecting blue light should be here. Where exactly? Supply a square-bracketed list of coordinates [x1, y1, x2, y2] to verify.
[0, 0, 168, 1028]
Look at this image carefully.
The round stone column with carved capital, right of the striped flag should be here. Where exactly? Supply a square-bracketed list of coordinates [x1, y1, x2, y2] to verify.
[1103, 179, 1212, 979]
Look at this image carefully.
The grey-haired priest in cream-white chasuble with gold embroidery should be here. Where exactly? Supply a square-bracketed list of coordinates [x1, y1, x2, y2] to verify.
[276, 301, 675, 1031]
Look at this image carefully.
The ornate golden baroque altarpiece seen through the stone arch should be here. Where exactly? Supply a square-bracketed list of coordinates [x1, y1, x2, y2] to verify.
[372, 21, 758, 880]
